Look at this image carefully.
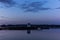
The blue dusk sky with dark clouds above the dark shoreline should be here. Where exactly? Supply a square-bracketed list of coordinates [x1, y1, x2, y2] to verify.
[0, 0, 60, 24]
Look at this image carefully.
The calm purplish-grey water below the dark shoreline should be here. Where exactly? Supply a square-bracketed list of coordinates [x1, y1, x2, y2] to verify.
[0, 29, 60, 40]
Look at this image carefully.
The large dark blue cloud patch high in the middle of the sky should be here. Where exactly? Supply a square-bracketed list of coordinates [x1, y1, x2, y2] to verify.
[21, 1, 50, 12]
